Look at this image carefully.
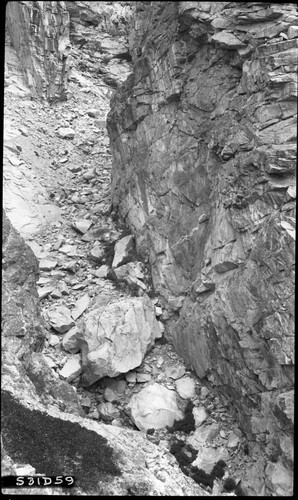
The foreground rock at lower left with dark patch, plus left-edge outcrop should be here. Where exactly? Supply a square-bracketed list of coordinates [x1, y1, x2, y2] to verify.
[1, 214, 209, 496]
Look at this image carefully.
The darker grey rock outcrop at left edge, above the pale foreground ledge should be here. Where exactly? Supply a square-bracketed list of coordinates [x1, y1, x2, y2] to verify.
[1, 210, 45, 359]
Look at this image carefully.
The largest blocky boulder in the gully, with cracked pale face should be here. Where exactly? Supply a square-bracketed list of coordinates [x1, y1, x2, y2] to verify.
[78, 296, 162, 385]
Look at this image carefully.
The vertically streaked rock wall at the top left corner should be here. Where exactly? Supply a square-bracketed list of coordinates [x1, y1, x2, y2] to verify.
[6, 1, 69, 101]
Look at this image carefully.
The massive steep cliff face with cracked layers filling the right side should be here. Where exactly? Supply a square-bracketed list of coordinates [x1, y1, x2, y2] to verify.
[108, 2, 298, 494]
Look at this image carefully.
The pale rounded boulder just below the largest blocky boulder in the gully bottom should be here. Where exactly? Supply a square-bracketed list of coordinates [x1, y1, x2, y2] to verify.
[128, 383, 183, 432]
